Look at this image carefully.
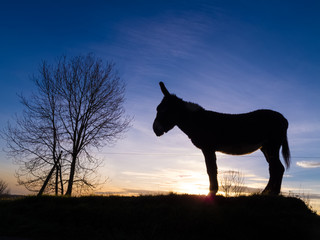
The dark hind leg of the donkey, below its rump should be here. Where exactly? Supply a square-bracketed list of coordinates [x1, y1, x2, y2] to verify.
[261, 145, 284, 195]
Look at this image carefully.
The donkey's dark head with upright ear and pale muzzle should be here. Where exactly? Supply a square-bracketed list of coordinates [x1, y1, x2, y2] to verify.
[153, 82, 182, 137]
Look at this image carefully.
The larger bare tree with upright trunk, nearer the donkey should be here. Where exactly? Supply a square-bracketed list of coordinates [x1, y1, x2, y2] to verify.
[54, 55, 129, 195]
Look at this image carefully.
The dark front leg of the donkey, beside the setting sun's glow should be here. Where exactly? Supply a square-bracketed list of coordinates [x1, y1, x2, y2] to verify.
[202, 149, 219, 196]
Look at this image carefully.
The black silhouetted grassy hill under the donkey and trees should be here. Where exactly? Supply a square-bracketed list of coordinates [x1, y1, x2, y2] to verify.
[0, 194, 320, 239]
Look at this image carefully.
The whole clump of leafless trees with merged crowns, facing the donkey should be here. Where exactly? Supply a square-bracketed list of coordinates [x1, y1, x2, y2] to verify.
[4, 54, 130, 195]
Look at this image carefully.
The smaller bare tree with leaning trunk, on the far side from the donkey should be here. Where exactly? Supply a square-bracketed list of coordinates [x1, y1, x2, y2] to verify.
[3, 62, 63, 195]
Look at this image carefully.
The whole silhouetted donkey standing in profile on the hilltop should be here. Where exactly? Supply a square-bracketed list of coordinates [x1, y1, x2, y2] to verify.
[153, 82, 290, 196]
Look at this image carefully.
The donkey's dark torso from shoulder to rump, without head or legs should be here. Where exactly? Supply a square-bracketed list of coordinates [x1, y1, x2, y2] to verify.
[189, 109, 288, 154]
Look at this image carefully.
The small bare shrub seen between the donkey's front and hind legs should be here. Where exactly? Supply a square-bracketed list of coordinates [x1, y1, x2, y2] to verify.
[220, 170, 245, 197]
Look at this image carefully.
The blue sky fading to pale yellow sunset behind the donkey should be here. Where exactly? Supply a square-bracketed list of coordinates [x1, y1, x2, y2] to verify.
[0, 0, 320, 206]
